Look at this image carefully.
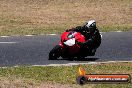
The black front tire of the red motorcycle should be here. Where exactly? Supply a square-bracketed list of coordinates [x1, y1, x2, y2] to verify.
[49, 45, 61, 60]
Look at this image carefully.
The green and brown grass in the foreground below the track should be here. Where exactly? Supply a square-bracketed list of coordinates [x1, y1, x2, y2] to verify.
[0, 62, 132, 88]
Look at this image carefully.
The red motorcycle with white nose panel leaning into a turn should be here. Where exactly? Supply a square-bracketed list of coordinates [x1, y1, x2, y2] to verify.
[49, 31, 96, 60]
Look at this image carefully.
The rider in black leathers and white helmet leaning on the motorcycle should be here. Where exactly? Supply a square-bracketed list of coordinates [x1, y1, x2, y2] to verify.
[66, 20, 101, 56]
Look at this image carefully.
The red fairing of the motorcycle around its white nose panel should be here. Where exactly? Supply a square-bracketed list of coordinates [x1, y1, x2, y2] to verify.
[59, 31, 85, 55]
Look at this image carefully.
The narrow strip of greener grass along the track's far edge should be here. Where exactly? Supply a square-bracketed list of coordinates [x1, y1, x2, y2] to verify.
[0, 26, 132, 36]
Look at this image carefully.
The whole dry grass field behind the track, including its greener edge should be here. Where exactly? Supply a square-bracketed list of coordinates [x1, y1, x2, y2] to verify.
[0, 0, 132, 35]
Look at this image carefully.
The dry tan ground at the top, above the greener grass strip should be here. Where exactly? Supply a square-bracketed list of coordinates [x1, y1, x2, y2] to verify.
[0, 0, 132, 27]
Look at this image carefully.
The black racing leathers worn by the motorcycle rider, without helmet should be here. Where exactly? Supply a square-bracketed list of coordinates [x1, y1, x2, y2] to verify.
[68, 26, 101, 55]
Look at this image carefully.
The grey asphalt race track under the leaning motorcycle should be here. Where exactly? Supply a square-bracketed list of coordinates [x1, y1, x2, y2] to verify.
[0, 32, 132, 66]
